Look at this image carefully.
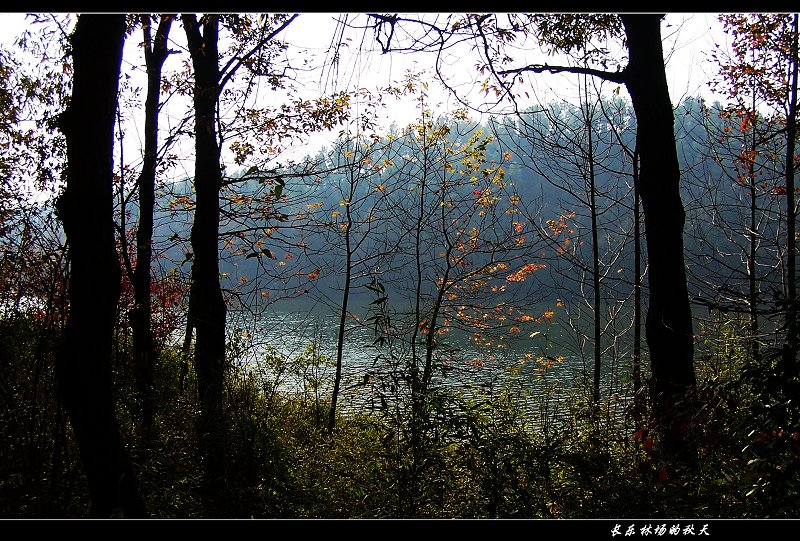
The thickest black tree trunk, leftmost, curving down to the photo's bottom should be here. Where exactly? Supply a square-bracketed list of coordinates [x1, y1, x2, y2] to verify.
[56, 15, 145, 517]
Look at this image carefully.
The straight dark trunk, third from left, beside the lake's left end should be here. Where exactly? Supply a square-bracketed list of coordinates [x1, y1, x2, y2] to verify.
[183, 15, 226, 515]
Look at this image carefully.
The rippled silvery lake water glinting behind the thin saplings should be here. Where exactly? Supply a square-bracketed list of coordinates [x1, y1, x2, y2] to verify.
[227, 304, 629, 422]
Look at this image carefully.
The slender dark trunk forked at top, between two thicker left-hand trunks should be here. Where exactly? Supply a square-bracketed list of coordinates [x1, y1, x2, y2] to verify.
[131, 15, 174, 435]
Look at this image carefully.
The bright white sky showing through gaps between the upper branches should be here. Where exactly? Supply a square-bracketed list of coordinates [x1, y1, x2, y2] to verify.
[0, 13, 724, 174]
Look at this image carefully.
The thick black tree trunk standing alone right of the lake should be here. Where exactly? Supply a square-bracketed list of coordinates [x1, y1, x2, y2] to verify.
[620, 14, 696, 454]
